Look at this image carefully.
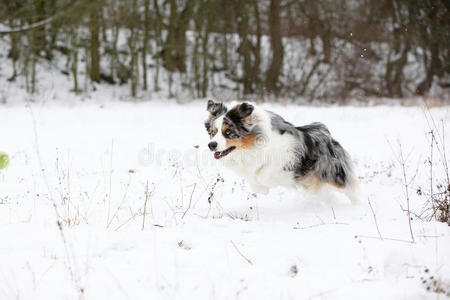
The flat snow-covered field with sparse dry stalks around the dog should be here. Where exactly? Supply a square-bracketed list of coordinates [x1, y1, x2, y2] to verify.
[0, 101, 450, 300]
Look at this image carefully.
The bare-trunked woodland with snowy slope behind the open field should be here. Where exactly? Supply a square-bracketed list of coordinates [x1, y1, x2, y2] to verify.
[0, 0, 450, 102]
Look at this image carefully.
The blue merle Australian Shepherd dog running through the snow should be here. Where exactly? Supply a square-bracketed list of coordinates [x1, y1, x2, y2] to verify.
[205, 100, 359, 203]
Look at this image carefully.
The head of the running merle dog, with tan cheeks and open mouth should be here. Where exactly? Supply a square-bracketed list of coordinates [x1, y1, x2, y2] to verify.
[205, 100, 256, 159]
